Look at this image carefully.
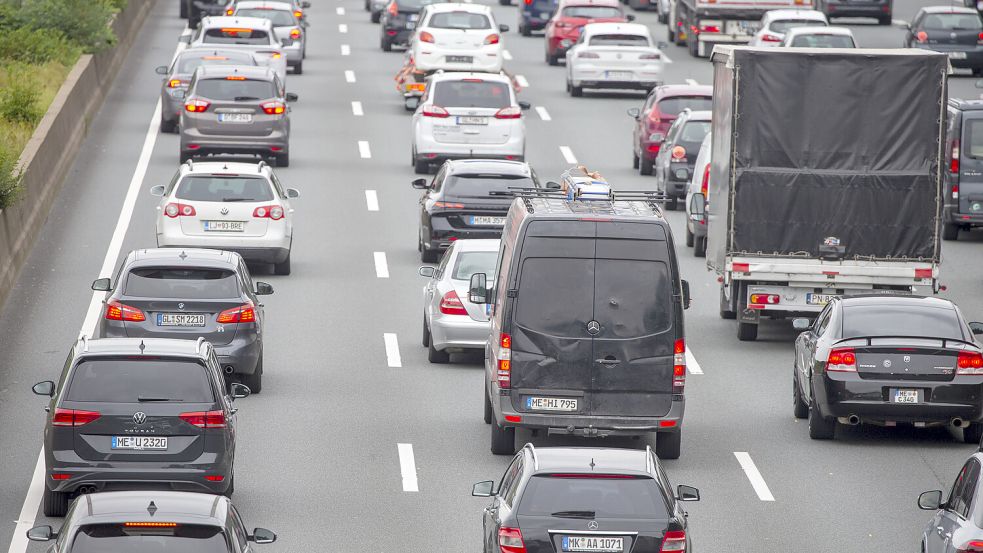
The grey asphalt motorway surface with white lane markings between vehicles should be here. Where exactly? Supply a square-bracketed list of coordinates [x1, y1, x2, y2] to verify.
[0, 0, 983, 553]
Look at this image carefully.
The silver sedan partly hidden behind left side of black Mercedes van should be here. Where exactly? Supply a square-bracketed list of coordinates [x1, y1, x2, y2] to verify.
[420, 239, 499, 363]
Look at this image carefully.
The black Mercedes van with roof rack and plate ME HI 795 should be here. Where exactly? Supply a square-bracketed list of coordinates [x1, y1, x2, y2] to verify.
[469, 195, 689, 459]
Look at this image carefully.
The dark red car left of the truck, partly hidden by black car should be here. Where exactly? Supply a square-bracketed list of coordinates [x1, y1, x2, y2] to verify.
[628, 84, 713, 175]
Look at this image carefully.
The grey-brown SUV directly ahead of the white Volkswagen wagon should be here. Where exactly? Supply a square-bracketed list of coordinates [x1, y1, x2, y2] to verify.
[180, 66, 297, 167]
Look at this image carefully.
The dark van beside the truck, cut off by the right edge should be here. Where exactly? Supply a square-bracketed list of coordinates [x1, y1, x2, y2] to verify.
[942, 99, 983, 240]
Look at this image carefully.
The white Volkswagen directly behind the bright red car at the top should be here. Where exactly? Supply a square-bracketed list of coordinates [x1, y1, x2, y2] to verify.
[567, 23, 664, 96]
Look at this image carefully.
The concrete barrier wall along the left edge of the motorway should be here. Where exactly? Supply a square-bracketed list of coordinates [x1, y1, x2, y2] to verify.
[0, 0, 155, 307]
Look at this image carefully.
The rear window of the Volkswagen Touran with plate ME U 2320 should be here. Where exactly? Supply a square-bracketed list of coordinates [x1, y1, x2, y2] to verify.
[65, 355, 215, 403]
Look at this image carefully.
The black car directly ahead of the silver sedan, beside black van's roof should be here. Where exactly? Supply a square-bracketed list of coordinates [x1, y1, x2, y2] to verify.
[412, 159, 539, 263]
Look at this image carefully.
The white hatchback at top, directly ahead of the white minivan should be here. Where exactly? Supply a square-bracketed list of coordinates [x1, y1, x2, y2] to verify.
[410, 3, 509, 73]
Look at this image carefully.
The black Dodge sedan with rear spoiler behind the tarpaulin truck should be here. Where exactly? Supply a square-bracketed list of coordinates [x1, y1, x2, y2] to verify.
[792, 295, 983, 443]
